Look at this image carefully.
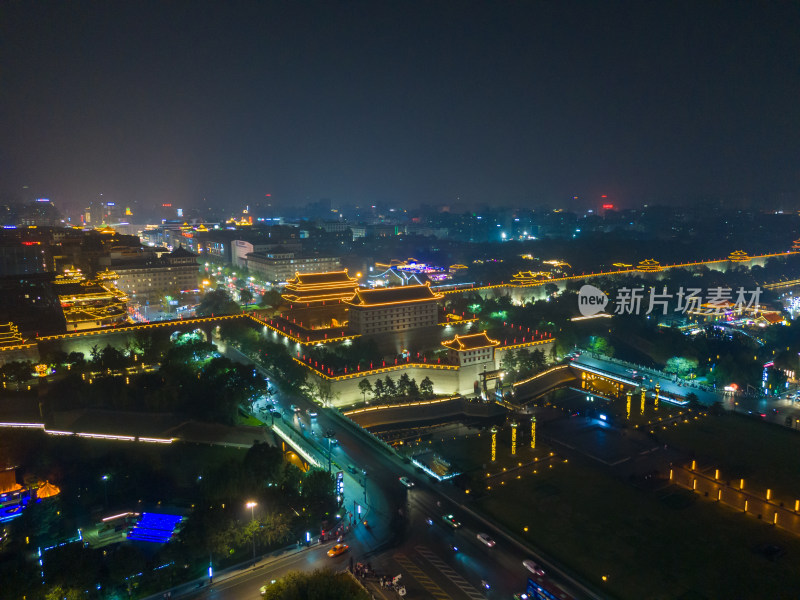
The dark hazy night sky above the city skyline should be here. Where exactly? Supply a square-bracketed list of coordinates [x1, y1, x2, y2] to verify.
[0, 0, 800, 213]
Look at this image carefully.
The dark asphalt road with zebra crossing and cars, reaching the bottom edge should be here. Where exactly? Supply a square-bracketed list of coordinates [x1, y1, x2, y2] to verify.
[205, 340, 596, 600]
